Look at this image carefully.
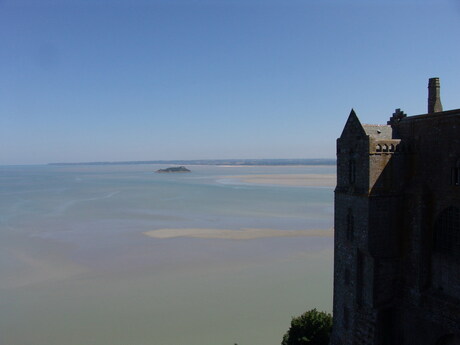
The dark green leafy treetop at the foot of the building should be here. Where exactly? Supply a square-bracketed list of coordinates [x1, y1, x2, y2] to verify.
[281, 309, 332, 345]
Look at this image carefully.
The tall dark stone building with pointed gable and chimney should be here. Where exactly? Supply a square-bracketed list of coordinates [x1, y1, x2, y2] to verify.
[331, 78, 460, 345]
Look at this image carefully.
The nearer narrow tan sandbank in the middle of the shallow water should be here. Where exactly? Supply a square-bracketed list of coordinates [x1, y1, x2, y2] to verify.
[144, 228, 334, 240]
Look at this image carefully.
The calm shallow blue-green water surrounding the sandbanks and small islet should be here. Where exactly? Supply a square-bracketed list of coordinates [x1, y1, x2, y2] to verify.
[0, 165, 335, 345]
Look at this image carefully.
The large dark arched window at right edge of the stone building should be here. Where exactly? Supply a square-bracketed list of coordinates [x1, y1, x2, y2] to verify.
[433, 206, 460, 260]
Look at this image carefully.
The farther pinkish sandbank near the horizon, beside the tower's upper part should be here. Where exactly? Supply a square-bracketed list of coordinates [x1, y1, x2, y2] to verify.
[225, 174, 336, 187]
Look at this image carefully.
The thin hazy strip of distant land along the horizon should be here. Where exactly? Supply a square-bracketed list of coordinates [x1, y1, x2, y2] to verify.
[47, 158, 336, 166]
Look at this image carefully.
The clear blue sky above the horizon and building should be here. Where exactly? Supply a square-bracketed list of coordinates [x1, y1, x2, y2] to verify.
[0, 0, 460, 164]
